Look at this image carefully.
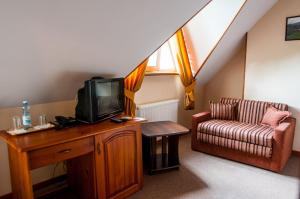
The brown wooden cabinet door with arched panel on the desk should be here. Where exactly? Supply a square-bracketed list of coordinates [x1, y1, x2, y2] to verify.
[95, 125, 143, 199]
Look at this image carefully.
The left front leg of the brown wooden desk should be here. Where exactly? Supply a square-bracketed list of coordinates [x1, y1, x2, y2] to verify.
[8, 146, 33, 199]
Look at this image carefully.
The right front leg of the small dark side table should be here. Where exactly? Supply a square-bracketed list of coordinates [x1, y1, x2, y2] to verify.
[168, 135, 179, 166]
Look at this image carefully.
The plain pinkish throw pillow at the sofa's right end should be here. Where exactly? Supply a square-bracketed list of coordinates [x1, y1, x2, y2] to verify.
[261, 106, 291, 128]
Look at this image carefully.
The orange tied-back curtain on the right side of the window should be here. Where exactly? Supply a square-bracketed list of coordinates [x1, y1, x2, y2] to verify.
[175, 29, 196, 110]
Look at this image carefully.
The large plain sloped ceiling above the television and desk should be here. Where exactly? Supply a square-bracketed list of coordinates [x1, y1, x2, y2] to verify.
[0, 0, 210, 108]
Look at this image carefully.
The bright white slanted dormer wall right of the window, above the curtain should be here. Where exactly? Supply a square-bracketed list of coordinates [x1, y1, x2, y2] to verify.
[184, 0, 245, 72]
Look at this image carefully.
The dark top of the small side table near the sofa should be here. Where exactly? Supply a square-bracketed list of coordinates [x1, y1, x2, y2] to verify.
[142, 121, 189, 137]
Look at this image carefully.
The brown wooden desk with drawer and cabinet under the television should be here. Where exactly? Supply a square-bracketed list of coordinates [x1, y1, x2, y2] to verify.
[0, 121, 143, 199]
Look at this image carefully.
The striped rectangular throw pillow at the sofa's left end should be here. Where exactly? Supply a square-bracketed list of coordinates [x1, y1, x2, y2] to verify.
[209, 101, 237, 120]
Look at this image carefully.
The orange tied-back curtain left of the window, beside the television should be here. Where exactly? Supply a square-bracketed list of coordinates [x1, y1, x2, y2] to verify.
[125, 59, 148, 117]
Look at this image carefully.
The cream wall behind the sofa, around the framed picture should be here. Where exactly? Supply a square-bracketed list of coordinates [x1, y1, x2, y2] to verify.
[245, 0, 300, 151]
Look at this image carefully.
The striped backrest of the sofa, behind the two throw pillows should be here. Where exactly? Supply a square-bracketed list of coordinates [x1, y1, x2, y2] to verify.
[220, 98, 288, 124]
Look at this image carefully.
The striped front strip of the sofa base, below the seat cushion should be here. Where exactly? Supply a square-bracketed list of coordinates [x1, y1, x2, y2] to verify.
[197, 133, 272, 158]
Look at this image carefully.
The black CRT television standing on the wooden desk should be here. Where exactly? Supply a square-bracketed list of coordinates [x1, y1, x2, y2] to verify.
[76, 77, 124, 123]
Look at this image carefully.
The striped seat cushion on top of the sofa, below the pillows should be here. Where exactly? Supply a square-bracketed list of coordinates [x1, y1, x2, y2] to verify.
[197, 120, 274, 148]
